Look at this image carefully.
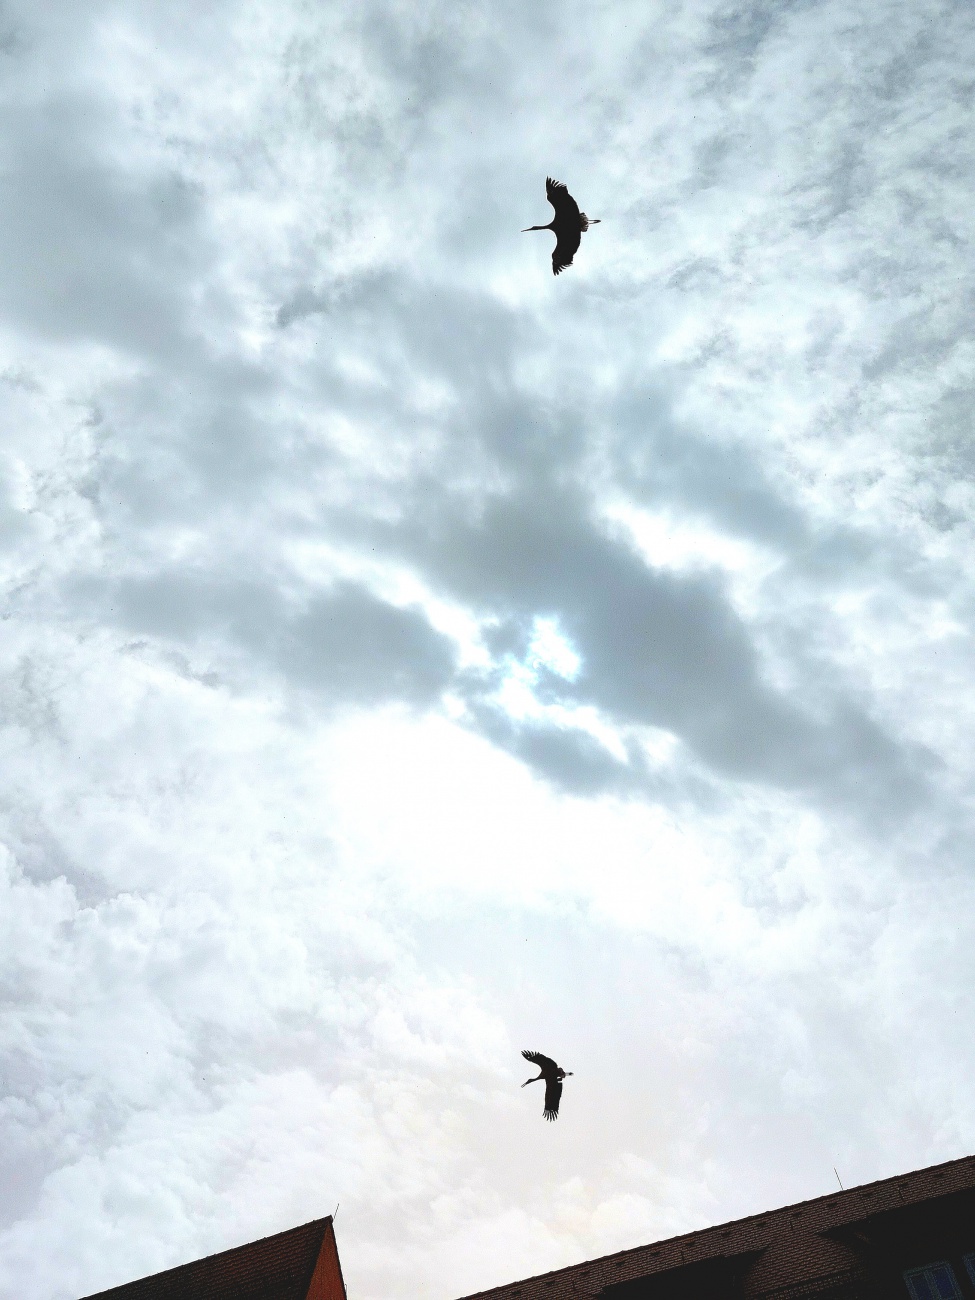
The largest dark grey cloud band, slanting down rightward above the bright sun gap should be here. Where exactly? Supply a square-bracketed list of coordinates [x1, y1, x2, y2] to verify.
[364, 490, 923, 806]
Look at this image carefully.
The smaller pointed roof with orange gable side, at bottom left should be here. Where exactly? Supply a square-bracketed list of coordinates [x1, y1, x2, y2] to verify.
[86, 1216, 345, 1300]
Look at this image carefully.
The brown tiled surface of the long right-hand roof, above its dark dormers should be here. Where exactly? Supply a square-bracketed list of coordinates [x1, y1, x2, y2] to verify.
[452, 1156, 975, 1300]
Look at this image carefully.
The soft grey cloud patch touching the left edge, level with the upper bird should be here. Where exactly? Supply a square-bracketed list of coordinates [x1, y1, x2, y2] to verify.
[0, 98, 205, 355]
